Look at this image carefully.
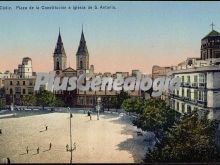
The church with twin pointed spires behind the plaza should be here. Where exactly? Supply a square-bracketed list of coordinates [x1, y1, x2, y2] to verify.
[53, 29, 140, 107]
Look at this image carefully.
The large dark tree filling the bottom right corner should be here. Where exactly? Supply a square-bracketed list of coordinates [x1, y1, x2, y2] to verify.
[145, 111, 220, 162]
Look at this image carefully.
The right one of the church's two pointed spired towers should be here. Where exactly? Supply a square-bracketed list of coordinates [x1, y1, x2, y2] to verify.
[76, 29, 89, 76]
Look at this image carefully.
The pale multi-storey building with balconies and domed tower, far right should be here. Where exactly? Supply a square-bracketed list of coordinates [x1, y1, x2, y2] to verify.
[167, 29, 220, 119]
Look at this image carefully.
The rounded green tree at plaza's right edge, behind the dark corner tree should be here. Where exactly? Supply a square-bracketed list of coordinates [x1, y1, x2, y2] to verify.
[131, 98, 179, 140]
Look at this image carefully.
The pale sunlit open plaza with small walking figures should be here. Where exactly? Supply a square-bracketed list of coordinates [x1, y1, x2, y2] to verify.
[0, 112, 153, 163]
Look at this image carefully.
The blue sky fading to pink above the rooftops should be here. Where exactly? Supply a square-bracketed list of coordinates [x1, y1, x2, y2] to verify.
[0, 1, 220, 73]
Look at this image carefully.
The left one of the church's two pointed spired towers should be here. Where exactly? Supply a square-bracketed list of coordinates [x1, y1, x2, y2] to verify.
[53, 29, 67, 71]
